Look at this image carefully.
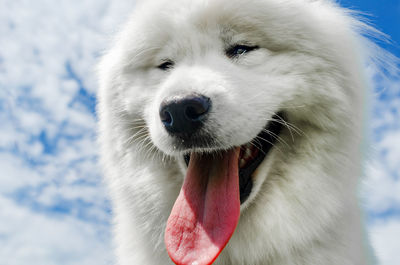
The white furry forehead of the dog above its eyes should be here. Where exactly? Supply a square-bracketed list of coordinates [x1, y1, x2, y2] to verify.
[120, 0, 340, 67]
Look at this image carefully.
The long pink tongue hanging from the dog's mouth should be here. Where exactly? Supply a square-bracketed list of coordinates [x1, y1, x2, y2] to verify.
[165, 148, 240, 265]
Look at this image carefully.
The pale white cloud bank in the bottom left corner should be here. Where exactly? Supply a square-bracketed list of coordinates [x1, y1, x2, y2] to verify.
[0, 197, 112, 265]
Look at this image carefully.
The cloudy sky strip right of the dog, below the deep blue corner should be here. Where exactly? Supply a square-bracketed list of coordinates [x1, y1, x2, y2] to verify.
[362, 66, 400, 265]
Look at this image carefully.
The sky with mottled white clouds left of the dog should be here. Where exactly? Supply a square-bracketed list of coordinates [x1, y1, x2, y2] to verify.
[0, 0, 134, 265]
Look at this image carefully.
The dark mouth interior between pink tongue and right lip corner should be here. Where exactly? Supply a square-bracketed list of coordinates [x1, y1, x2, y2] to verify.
[184, 113, 285, 203]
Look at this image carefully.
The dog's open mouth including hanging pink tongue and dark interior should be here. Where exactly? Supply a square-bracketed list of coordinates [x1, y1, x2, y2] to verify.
[165, 114, 284, 264]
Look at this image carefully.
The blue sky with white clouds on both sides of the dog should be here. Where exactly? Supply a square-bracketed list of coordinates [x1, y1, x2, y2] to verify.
[0, 0, 400, 265]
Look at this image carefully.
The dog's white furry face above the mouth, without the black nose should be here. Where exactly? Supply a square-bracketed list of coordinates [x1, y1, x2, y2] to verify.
[116, 0, 354, 155]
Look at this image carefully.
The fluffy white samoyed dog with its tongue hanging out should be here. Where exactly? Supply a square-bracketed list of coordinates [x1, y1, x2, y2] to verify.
[98, 0, 376, 265]
